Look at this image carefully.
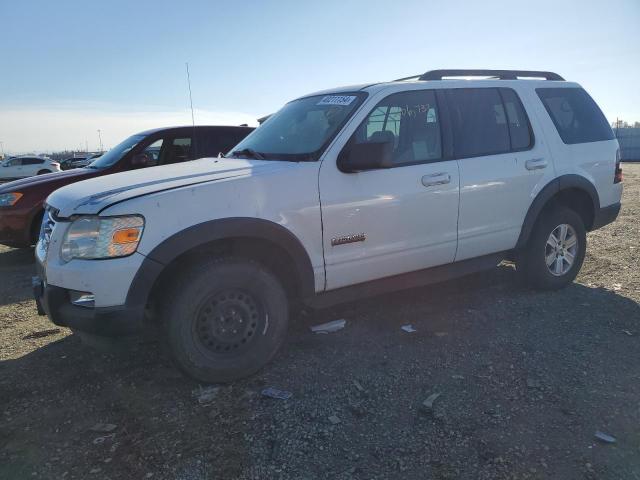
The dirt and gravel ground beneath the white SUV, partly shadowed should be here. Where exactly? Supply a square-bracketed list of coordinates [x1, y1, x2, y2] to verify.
[0, 164, 640, 480]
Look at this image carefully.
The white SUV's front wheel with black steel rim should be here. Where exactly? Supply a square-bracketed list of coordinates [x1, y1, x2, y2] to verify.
[163, 257, 289, 383]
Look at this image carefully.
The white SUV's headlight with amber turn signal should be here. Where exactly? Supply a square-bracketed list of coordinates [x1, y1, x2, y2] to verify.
[60, 215, 144, 262]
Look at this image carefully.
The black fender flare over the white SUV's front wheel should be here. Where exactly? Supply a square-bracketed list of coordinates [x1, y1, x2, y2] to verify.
[126, 217, 315, 306]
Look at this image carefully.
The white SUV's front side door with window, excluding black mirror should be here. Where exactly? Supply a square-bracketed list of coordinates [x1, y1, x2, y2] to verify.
[320, 90, 459, 290]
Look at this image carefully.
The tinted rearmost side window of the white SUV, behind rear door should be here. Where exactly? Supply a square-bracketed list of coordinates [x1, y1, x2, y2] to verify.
[536, 88, 614, 145]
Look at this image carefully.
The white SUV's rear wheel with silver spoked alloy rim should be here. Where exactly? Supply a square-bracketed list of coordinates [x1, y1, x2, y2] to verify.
[516, 207, 587, 290]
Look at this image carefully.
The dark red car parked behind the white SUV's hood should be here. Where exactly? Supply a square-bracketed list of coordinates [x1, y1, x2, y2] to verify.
[0, 126, 253, 247]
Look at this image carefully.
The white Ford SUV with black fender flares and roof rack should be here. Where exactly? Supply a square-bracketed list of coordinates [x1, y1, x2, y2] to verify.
[34, 70, 622, 382]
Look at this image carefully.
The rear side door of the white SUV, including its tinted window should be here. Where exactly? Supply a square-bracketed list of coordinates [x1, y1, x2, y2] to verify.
[445, 88, 554, 261]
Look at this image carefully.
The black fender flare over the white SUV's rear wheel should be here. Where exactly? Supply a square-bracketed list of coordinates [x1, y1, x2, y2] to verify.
[515, 174, 600, 249]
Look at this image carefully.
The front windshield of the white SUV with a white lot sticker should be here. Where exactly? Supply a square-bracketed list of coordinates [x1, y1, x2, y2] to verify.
[227, 92, 365, 161]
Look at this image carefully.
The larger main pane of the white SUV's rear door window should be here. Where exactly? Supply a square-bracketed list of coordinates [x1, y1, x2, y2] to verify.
[445, 88, 511, 158]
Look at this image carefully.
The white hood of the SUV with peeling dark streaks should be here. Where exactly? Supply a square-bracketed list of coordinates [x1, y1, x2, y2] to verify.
[47, 158, 296, 217]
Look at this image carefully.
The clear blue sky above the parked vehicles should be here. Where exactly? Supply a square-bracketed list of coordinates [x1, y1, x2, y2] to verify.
[0, 0, 640, 152]
